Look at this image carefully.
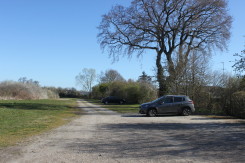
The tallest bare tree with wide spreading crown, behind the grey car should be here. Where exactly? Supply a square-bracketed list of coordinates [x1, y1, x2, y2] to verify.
[98, 0, 232, 95]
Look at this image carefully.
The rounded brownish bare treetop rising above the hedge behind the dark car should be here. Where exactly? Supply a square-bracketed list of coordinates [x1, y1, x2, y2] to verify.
[100, 69, 125, 83]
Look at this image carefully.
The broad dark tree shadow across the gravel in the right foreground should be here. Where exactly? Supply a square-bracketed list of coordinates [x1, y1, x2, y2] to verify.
[66, 122, 245, 162]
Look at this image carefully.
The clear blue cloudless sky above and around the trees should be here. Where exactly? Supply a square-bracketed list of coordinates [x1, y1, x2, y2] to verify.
[0, 0, 245, 88]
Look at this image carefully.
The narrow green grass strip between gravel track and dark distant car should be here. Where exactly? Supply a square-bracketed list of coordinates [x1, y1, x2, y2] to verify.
[84, 99, 139, 113]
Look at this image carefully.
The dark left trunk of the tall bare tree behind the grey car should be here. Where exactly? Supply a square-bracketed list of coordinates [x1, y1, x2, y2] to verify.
[156, 52, 168, 97]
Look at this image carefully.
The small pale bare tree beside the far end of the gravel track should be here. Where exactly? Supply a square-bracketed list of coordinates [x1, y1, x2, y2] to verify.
[76, 68, 96, 92]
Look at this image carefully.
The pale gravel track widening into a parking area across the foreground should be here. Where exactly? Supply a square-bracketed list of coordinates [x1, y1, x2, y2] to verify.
[0, 100, 245, 163]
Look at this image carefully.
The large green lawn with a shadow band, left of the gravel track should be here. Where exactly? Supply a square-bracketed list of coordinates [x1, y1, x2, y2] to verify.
[0, 99, 80, 147]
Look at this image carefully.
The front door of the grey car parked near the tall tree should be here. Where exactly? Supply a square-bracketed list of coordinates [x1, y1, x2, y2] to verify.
[157, 96, 173, 114]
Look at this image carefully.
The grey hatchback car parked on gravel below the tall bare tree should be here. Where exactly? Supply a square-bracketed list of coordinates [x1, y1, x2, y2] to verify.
[139, 95, 195, 117]
